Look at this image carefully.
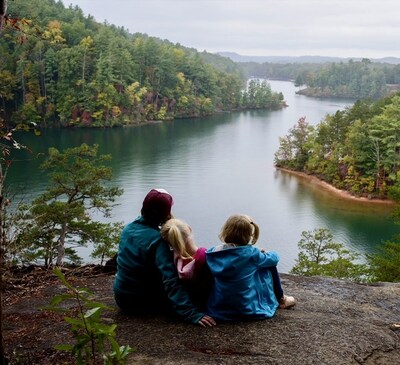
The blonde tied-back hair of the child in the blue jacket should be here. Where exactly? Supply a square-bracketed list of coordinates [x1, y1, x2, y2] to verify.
[219, 214, 260, 246]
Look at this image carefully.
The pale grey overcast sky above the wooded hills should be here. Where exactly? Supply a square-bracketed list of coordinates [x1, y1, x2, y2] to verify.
[62, 0, 400, 58]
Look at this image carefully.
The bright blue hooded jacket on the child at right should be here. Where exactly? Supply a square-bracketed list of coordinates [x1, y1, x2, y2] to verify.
[206, 245, 279, 321]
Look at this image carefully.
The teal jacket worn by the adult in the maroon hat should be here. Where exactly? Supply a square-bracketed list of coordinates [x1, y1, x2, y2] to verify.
[114, 217, 204, 323]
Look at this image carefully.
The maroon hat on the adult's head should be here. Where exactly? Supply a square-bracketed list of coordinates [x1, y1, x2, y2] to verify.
[142, 189, 174, 225]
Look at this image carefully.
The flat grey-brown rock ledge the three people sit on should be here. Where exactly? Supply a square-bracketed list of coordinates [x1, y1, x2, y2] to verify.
[5, 274, 400, 365]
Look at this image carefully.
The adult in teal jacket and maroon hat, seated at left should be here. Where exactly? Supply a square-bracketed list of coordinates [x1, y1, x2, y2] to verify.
[114, 189, 215, 327]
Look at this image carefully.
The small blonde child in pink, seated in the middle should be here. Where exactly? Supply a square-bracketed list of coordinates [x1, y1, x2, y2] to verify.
[161, 218, 212, 307]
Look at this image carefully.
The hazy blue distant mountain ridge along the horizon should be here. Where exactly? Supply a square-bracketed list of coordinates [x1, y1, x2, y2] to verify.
[217, 52, 400, 65]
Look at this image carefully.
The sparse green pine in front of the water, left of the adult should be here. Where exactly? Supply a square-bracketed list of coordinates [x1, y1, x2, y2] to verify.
[14, 144, 122, 266]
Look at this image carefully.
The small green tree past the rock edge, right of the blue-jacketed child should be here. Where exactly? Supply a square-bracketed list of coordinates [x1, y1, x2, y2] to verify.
[290, 228, 367, 281]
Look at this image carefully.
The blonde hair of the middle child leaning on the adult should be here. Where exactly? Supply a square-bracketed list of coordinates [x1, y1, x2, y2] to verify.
[160, 218, 192, 259]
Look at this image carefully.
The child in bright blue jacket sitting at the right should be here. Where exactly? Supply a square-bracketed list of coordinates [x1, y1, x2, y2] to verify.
[206, 215, 296, 320]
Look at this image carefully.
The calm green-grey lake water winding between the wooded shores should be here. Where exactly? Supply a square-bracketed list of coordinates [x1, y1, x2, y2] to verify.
[9, 81, 398, 272]
